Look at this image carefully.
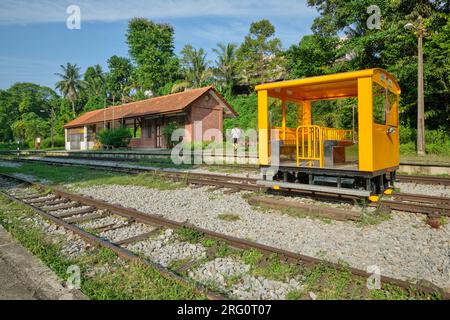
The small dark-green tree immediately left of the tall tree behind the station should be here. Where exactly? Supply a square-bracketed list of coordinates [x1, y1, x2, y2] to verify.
[106, 56, 133, 103]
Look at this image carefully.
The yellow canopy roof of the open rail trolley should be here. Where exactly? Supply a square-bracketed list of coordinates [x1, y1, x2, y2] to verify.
[256, 69, 400, 101]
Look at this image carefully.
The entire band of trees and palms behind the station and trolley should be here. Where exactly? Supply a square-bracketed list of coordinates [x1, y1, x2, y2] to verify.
[0, 0, 450, 153]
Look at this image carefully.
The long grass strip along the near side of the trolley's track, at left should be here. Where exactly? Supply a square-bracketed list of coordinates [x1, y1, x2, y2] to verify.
[0, 163, 184, 190]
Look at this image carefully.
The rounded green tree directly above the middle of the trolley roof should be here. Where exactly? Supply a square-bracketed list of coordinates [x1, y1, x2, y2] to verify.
[286, 35, 339, 78]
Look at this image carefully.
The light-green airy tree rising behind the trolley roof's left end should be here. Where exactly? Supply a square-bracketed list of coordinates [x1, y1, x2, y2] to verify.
[237, 20, 284, 85]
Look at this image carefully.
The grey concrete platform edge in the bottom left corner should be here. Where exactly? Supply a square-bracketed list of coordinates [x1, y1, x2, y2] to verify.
[0, 226, 87, 300]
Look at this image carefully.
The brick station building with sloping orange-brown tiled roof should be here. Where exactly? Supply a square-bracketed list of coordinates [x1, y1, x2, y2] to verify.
[64, 87, 237, 151]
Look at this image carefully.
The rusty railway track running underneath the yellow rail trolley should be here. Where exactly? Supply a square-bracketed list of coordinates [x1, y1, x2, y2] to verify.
[2, 159, 450, 216]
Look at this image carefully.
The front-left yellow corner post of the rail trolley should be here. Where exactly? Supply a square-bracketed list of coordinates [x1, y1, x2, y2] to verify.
[258, 90, 269, 165]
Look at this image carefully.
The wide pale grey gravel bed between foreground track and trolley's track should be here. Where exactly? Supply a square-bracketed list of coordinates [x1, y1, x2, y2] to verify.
[78, 182, 450, 290]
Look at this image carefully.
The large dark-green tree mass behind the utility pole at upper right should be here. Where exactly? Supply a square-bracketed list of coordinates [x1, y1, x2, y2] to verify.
[308, 0, 450, 130]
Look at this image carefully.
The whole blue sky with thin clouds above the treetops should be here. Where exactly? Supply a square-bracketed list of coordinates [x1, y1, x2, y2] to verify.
[0, 0, 317, 89]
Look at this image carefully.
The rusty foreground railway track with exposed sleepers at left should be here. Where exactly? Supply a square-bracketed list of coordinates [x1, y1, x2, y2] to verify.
[0, 174, 450, 300]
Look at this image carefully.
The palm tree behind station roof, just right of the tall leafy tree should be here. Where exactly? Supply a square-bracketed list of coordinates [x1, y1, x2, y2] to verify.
[172, 45, 212, 92]
